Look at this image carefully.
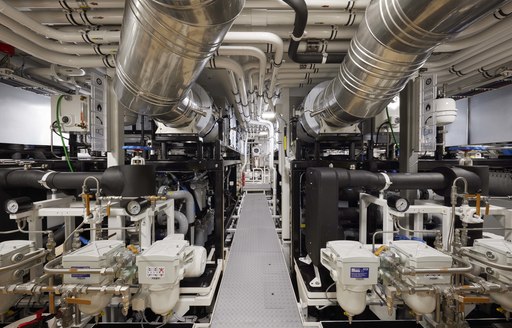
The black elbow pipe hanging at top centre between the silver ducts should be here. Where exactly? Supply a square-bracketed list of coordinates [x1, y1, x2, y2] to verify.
[283, 0, 345, 64]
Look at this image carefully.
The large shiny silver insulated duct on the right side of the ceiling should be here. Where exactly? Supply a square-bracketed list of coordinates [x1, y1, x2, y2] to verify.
[301, 0, 508, 133]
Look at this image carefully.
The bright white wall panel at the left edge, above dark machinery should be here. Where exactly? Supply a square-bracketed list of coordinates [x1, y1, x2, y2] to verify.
[0, 83, 52, 145]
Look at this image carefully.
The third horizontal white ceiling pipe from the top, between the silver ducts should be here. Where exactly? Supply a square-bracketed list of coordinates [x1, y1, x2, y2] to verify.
[228, 24, 357, 41]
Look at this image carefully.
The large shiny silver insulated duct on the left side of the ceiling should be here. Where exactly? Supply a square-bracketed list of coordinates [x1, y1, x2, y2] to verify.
[115, 0, 244, 127]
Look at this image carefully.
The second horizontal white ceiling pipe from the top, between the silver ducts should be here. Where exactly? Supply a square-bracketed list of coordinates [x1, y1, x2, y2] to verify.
[234, 9, 364, 29]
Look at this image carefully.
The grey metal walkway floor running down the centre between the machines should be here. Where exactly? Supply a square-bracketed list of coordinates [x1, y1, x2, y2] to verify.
[210, 193, 302, 328]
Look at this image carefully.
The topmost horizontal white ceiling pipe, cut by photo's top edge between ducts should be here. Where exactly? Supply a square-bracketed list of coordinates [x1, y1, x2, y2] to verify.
[245, 0, 370, 11]
